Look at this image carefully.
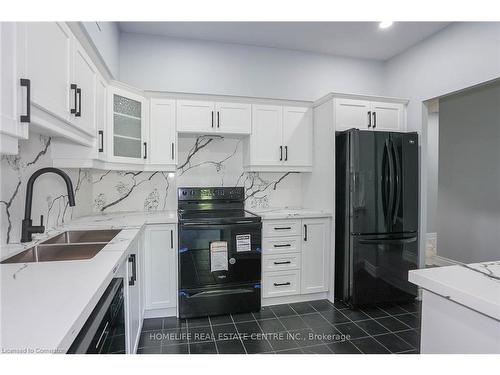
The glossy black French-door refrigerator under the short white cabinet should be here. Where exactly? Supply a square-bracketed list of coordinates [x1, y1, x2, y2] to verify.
[335, 129, 419, 307]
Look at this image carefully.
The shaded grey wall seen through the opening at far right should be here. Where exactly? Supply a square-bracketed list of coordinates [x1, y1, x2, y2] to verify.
[437, 83, 500, 263]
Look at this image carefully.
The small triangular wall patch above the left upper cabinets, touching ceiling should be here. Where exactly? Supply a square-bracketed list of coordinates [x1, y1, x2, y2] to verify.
[82, 21, 120, 78]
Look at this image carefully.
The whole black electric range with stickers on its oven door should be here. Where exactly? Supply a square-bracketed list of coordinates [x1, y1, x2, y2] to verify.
[178, 187, 262, 318]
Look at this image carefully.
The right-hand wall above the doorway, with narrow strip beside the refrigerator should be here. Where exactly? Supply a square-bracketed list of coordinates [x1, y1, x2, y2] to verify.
[384, 22, 500, 267]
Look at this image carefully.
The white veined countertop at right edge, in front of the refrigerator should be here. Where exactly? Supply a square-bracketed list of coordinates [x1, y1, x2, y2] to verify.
[408, 261, 500, 320]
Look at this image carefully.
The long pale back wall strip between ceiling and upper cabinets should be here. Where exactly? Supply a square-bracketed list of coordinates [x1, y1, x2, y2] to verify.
[120, 33, 384, 100]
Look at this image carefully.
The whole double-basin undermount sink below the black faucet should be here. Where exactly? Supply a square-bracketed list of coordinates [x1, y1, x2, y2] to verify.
[0, 229, 120, 263]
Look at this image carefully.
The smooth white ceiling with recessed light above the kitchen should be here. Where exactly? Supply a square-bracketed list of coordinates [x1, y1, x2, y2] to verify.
[118, 22, 449, 60]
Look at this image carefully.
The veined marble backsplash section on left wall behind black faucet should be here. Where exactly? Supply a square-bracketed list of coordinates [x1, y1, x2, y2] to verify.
[0, 134, 92, 244]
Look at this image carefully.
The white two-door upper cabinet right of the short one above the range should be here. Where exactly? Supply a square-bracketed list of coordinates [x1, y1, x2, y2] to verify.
[244, 104, 313, 172]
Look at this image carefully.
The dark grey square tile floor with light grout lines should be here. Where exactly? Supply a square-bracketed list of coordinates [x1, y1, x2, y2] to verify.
[138, 300, 421, 354]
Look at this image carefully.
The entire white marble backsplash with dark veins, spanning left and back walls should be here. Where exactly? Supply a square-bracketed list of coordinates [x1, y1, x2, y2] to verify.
[0, 134, 302, 244]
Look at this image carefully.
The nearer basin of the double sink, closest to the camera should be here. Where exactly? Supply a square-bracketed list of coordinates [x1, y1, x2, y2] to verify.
[1, 243, 106, 263]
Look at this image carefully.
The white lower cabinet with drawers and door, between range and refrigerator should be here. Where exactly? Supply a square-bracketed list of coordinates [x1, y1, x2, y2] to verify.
[262, 218, 331, 304]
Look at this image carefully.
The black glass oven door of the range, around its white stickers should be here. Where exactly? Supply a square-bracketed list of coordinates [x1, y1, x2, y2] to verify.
[179, 224, 261, 289]
